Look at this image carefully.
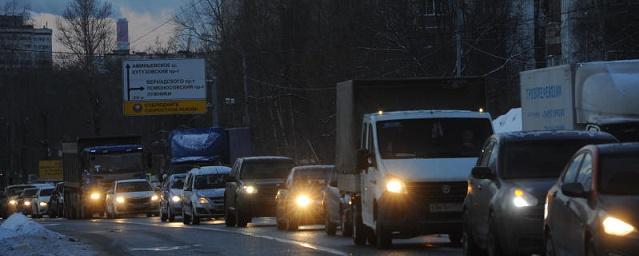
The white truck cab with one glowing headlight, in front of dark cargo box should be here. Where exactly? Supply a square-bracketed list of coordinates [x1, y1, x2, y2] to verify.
[353, 110, 493, 248]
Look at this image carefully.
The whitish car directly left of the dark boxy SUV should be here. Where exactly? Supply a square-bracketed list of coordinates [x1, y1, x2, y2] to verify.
[182, 166, 231, 225]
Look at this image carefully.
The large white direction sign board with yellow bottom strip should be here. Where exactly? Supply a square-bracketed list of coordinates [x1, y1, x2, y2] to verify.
[122, 59, 207, 116]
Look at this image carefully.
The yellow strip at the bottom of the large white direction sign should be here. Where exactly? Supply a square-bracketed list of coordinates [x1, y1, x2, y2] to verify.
[124, 100, 206, 116]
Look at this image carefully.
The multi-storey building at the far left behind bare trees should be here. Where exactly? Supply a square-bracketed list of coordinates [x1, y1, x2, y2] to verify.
[0, 15, 53, 71]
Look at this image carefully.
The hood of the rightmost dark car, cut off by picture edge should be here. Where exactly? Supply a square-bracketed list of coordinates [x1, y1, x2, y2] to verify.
[599, 194, 639, 229]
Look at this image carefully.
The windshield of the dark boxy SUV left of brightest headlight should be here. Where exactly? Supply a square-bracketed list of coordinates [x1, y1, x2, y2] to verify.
[240, 161, 293, 179]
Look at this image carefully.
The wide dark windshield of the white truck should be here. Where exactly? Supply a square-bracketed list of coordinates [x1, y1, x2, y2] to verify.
[377, 118, 492, 159]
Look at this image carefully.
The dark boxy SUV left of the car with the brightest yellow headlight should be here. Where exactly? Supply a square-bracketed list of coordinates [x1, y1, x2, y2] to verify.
[224, 156, 295, 227]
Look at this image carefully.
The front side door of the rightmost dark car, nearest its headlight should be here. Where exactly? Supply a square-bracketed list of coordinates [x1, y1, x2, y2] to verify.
[562, 151, 592, 255]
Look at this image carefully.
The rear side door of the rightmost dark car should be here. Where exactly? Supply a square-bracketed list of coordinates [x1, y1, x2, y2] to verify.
[547, 153, 584, 254]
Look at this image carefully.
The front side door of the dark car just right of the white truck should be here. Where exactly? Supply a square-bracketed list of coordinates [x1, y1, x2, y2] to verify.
[473, 141, 500, 241]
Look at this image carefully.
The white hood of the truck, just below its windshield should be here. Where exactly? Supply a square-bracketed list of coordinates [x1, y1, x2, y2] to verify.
[380, 157, 477, 182]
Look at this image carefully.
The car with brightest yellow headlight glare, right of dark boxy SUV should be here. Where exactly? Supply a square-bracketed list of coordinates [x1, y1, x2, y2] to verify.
[275, 165, 335, 231]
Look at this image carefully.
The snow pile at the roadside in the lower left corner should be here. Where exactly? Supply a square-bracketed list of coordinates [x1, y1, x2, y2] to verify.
[0, 213, 95, 256]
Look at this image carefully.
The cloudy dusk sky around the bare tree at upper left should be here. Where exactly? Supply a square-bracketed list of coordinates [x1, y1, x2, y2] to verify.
[0, 0, 189, 51]
